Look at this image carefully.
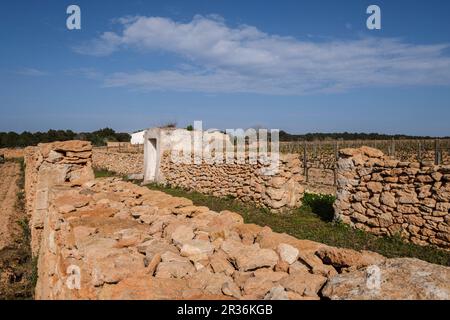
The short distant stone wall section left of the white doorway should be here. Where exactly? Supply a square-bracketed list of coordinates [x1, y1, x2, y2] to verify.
[92, 148, 144, 175]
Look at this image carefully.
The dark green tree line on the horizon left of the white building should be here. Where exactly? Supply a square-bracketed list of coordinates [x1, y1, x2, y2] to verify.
[0, 128, 131, 148]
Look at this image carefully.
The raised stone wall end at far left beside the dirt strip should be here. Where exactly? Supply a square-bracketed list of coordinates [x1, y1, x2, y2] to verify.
[24, 141, 94, 255]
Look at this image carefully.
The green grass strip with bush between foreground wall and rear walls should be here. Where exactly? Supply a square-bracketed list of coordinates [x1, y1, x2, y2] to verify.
[144, 185, 450, 266]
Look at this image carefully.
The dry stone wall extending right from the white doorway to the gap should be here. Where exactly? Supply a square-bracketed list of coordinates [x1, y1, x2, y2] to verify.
[159, 152, 304, 212]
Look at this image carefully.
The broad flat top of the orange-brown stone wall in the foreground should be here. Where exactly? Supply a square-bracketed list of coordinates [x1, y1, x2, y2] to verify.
[36, 178, 450, 300]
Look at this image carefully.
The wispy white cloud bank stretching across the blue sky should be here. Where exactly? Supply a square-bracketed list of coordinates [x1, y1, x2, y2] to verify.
[77, 16, 450, 95]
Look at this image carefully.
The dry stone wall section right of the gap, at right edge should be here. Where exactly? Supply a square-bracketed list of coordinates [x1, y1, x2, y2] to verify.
[335, 147, 450, 249]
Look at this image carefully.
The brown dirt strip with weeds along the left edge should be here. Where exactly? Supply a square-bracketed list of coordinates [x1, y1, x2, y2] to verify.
[0, 161, 34, 300]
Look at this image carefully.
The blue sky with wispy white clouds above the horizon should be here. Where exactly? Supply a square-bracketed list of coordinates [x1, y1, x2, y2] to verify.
[0, 0, 450, 136]
